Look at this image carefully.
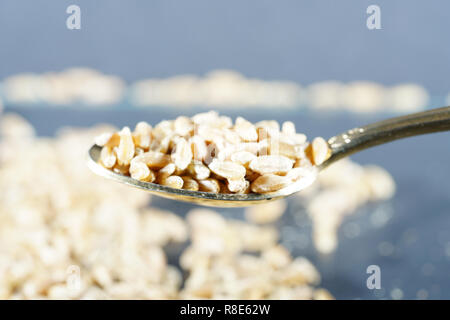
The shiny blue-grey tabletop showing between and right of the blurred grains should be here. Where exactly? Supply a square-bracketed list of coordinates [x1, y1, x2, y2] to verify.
[7, 108, 450, 299]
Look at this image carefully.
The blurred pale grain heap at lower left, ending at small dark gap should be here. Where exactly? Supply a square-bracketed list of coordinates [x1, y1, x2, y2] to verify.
[0, 115, 187, 298]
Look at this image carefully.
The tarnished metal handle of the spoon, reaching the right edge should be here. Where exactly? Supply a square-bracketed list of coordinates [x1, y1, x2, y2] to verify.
[322, 107, 450, 167]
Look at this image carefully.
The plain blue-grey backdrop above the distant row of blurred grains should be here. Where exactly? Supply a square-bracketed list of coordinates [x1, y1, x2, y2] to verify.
[0, 0, 450, 95]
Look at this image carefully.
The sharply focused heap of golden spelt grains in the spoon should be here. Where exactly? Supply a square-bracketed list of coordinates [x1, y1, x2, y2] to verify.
[97, 112, 329, 193]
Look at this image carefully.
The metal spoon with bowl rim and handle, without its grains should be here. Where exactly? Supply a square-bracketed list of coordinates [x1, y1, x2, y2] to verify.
[88, 107, 450, 207]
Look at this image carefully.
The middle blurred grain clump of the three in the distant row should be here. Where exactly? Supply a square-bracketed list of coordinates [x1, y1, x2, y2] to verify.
[130, 70, 305, 108]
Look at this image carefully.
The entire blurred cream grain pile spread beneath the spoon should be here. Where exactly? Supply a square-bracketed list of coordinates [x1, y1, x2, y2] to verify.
[0, 114, 342, 299]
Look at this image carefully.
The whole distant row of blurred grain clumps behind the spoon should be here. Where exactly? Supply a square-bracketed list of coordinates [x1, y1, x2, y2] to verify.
[0, 68, 430, 113]
